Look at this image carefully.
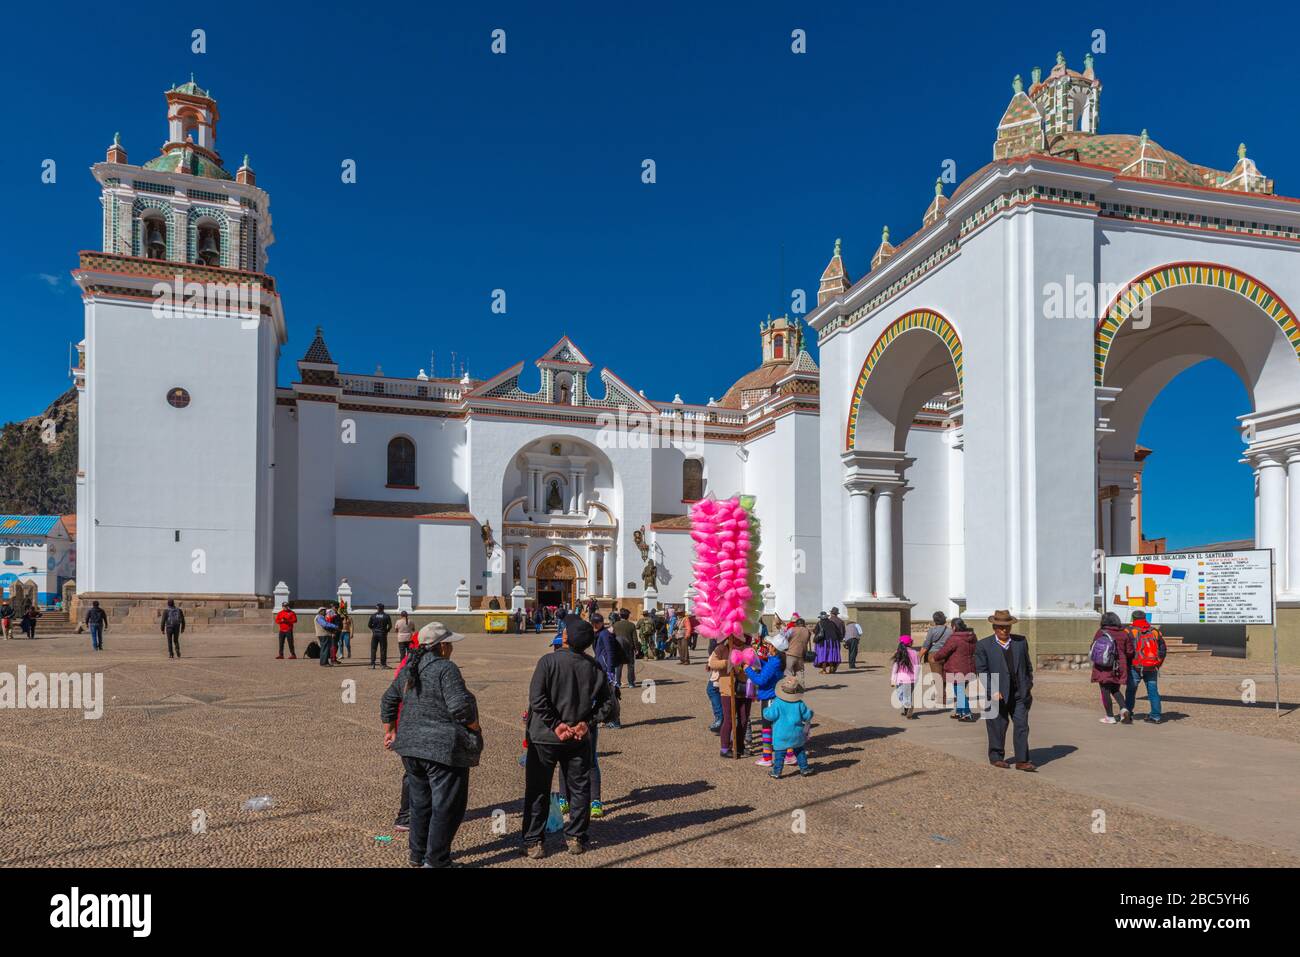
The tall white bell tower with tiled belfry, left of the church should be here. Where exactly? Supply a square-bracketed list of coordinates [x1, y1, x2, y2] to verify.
[73, 77, 286, 607]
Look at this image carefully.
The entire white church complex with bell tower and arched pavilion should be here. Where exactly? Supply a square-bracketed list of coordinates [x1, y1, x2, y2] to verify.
[74, 56, 1300, 653]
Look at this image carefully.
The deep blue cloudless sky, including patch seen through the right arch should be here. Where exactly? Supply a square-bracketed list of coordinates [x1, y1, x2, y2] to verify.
[0, 3, 1300, 544]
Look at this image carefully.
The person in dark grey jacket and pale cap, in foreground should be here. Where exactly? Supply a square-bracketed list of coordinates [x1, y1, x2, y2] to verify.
[380, 622, 484, 867]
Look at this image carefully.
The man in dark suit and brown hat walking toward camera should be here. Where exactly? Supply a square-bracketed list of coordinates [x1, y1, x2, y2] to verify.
[975, 609, 1037, 771]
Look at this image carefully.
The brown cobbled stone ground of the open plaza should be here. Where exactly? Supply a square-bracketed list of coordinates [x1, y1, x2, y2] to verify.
[0, 632, 1300, 867]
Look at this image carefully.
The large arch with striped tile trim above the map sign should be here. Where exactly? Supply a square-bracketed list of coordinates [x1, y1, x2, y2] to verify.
[1096, 264, 1300, 621]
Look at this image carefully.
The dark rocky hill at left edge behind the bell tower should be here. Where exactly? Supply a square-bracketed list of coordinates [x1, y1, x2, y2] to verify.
[0, 387, 77, 515]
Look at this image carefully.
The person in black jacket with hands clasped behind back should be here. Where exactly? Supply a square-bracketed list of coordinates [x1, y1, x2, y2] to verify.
[524, 615, 614, 859]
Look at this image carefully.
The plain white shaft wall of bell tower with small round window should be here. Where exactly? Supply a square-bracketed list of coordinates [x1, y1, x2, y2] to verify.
[79, 303, 274, 594]
